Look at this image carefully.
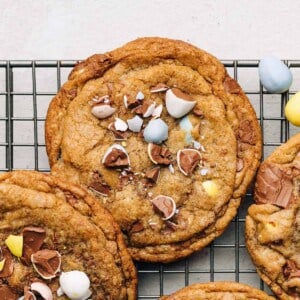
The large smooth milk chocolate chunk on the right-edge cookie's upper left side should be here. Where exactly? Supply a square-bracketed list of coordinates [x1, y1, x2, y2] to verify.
[255, 163, 293, 208]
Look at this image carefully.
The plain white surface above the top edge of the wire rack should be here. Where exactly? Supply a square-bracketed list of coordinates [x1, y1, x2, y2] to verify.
[0, 0, 300, 59]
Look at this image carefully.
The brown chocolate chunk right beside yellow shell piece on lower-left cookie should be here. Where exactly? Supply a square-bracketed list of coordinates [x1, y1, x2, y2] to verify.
[22, 227, 46, 265]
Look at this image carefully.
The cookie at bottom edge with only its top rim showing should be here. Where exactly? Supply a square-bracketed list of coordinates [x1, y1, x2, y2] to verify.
[161, 281, 274, 300]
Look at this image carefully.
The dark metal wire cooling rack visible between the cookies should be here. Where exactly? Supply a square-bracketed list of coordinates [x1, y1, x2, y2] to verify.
[0, 60, 300, 299]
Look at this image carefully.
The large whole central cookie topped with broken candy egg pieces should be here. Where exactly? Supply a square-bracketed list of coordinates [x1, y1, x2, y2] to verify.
[46, 38, 261, 262]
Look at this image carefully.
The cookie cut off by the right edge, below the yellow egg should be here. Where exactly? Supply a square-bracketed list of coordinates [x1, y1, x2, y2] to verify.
[246, 134, 300, 299]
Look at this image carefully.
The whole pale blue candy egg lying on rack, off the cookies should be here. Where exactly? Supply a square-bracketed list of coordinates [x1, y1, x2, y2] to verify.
[258, 56, 293, 93]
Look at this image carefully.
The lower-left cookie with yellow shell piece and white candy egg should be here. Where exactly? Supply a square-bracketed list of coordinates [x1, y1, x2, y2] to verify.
[0, 171, 137, 300]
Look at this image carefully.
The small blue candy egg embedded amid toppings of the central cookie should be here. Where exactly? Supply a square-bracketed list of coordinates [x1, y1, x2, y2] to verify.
[144, 119, 169, 144]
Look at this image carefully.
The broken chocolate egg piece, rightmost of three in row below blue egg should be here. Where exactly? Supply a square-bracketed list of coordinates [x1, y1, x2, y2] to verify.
[177, 149, 201, 175]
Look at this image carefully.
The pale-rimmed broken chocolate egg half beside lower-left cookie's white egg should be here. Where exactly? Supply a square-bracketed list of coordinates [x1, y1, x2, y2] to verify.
[31, 249, 61, 279]
